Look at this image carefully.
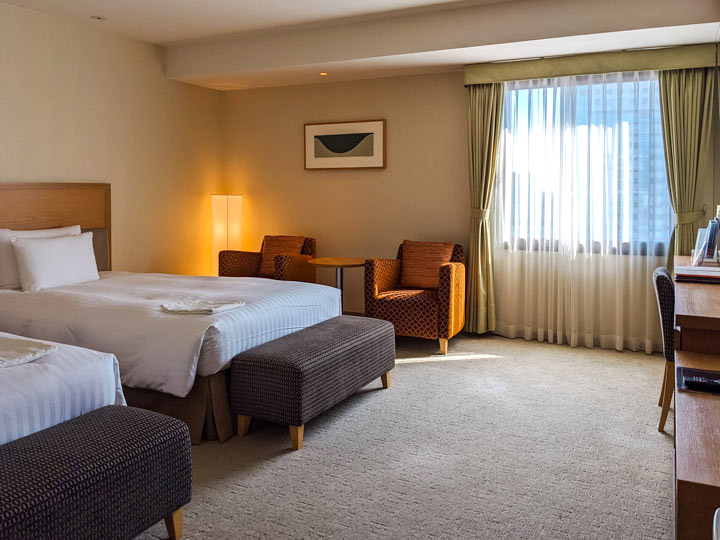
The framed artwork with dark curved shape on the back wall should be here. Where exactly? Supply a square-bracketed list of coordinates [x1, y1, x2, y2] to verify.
[305, 120, 385, 169]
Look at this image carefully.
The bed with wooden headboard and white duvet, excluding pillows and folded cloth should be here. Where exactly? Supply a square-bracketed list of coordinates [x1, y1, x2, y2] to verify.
[0, 183, 341, 444]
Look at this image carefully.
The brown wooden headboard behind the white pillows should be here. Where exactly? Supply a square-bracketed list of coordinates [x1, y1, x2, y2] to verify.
[0, 182, 112, 270]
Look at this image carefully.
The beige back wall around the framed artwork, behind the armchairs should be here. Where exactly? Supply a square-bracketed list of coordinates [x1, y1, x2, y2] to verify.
[222, 73, 470, 311]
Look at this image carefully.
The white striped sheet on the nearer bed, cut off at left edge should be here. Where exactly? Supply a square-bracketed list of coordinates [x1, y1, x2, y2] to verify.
[0, 332, 125, 444]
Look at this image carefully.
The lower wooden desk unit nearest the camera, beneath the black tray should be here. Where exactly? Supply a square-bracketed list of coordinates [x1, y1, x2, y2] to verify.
[675, 350, 720, 540]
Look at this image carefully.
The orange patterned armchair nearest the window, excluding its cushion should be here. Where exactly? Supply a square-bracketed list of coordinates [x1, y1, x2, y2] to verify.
[365, 244, 465, 354]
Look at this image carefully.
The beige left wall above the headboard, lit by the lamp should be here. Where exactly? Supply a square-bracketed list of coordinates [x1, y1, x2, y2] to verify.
[0, 3, 221, 273]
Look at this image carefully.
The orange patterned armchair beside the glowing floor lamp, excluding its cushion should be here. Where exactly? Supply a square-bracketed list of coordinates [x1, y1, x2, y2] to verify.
[218, 236, 317, 283]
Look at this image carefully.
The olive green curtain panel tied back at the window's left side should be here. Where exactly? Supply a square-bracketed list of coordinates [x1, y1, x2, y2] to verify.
[465, 83, 504, 334]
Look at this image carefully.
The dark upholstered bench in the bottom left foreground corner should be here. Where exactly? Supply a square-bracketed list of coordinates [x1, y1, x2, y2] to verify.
[0, 405, 192, 540]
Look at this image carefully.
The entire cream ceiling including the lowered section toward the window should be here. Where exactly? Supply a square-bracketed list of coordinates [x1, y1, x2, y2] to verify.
[0, 0, 720, 90]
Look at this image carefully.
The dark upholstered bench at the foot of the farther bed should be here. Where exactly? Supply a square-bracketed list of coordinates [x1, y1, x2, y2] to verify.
[230, 316, 395, 450]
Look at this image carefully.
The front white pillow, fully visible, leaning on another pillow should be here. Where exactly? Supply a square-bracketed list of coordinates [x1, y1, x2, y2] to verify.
[10, 232, 100, 291]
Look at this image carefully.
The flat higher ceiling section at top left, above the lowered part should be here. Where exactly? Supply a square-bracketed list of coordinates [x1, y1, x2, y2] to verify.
[3, 0, 509, 44]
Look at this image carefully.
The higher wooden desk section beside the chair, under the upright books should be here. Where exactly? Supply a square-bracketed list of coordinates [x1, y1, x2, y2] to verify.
[675, 257, 720, 354]
